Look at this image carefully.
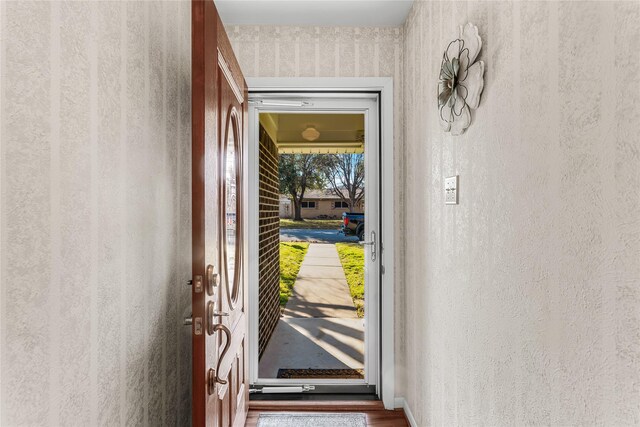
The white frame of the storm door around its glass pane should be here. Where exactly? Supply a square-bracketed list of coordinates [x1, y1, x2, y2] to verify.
[248, 97, 380, 393]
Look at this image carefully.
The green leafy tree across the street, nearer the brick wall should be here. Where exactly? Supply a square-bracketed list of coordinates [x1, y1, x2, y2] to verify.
[278, 154, 324, 221]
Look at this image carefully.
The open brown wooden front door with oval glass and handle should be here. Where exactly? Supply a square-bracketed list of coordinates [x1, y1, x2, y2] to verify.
[192, 0, 249, 427]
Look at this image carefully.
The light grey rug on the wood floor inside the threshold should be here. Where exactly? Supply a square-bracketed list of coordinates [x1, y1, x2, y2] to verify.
[258, 413, 367, 427]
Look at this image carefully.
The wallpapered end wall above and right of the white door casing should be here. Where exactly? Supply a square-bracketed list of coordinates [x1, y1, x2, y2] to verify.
[227, 25, 404, 392]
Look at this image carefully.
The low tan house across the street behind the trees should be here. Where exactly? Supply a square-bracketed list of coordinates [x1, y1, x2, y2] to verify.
[280, 190, 364, 219]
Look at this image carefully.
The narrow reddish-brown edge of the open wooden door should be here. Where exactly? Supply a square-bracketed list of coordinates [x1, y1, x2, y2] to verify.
[191, 1, 219, 426]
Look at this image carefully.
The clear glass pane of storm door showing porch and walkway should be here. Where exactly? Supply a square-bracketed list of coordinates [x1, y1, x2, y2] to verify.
[258, 112, 376, 382]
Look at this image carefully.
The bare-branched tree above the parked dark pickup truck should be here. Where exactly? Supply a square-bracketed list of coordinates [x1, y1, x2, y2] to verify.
[322, 154, 364, 211]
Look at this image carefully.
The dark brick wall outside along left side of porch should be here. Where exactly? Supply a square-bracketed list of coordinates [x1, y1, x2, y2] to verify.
[258, 126, 280, 356]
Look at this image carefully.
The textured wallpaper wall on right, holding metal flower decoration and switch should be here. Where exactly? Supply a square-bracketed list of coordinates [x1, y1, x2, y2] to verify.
[399, 1, 640, 426]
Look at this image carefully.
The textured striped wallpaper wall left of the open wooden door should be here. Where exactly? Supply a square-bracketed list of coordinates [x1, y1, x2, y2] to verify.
[0, 1, 191, 426]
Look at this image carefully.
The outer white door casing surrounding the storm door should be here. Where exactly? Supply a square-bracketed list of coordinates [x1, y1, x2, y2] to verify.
[244, 77, 395, 409]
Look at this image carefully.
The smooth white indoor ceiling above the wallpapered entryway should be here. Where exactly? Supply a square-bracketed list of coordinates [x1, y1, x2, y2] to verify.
[216, 0, 413, 27]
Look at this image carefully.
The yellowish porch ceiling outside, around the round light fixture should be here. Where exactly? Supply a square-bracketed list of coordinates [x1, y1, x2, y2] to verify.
[260, 113, 364, 154]
